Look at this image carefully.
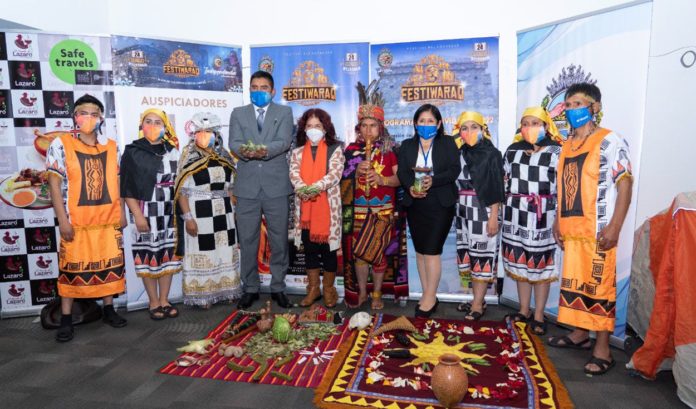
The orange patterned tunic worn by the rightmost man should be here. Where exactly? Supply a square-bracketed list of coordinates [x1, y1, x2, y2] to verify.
[557, 128, 616, 331]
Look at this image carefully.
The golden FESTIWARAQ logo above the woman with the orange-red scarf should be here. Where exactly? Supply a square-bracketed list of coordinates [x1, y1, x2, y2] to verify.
[283, 61, 336, 106]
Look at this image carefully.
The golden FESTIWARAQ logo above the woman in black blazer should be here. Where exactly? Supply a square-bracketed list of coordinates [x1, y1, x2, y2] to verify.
[401, 54, 464, 105]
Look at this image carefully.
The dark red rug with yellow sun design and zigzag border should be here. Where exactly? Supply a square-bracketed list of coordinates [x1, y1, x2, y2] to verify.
[314, 314, 573, 409]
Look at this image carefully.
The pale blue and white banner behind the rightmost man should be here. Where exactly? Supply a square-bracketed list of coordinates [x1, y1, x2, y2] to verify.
[503, 3, 652, 339]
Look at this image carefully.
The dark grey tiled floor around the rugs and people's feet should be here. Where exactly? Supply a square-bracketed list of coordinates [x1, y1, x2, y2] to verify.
[0, 297, 686, 409]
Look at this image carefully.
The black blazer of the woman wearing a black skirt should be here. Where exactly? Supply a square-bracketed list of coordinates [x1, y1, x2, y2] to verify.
[396, 135, 462, 207]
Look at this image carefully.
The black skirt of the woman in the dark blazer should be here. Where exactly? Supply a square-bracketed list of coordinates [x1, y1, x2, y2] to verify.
[406, 195, 455, 256]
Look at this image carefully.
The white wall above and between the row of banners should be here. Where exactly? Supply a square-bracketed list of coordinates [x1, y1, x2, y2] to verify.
[0, 0, 631, 152]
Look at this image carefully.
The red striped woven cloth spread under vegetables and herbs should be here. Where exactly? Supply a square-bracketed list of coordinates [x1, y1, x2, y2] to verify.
[160, 311, 351, 388]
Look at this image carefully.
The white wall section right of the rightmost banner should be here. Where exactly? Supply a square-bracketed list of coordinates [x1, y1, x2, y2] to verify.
[636, 0, 696, 226]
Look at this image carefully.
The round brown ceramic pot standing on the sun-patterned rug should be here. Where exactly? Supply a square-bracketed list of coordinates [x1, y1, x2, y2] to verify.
[431, 354, 469, 408]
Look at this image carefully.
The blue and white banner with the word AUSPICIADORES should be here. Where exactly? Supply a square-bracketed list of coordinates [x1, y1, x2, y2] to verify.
[111, 36, 242, 309]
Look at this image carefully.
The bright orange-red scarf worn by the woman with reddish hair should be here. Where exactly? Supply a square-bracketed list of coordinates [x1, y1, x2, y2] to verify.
[300, 139, 331, 243]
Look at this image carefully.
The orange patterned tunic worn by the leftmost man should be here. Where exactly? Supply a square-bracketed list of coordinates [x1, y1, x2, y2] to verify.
[58, 135, 125, 298]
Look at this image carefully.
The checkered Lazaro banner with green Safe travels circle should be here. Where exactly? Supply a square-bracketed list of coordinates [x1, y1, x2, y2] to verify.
[0, 31, 116, 317]
